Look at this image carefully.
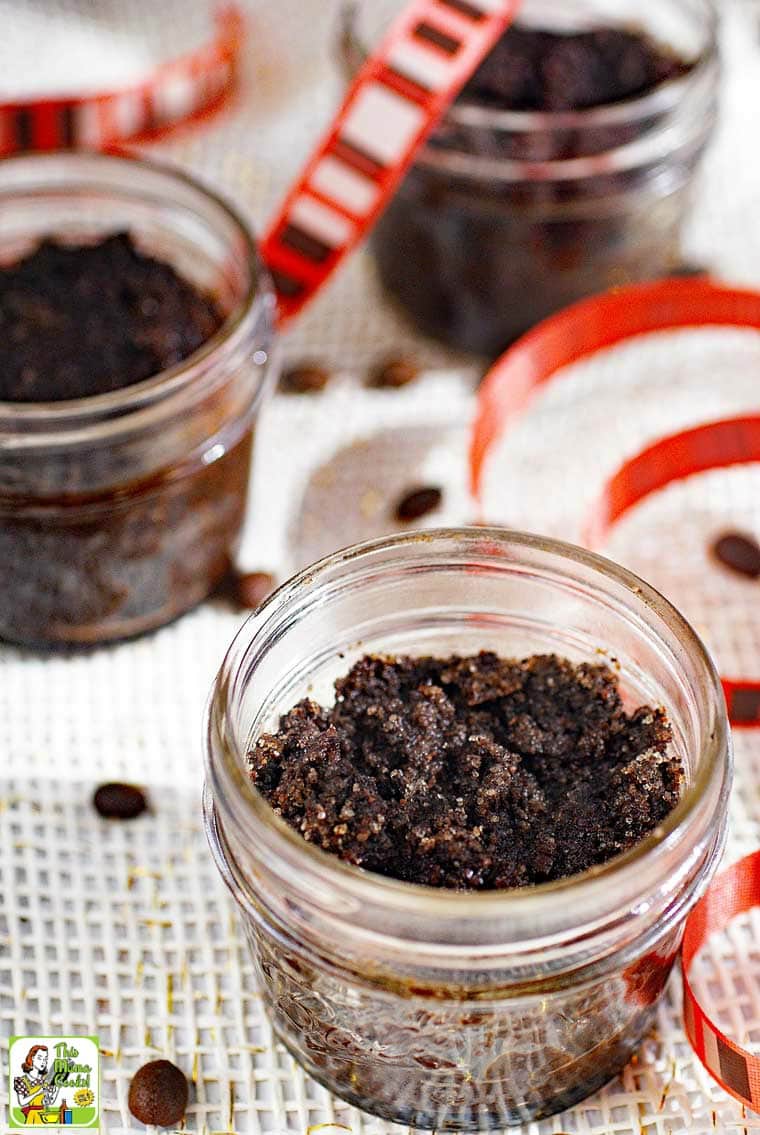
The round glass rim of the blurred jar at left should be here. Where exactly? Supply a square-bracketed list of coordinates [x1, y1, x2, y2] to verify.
[0, 150, 276, 433]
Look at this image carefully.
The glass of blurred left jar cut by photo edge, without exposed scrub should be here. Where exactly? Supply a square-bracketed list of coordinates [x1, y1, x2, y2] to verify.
[0, 153, 275, 646]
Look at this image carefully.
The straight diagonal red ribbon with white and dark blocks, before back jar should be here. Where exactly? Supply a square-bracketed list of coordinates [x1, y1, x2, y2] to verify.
[261, 0, 520, 321]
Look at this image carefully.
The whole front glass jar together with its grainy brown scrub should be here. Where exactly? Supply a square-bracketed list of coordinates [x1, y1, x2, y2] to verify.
[204, 528, 731, 1130]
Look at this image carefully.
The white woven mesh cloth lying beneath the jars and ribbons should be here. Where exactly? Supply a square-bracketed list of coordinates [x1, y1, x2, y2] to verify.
[0, 0, 760, 1135]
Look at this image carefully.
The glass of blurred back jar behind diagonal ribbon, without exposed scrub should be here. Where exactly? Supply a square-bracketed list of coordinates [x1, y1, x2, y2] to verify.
[341, 0, 719, 356]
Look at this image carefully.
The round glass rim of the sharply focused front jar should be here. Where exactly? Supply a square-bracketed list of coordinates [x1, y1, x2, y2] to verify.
[205, 528, 731, 935]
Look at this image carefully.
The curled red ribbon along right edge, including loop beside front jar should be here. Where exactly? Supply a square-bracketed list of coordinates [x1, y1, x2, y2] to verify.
[470, 279, 760, 1111]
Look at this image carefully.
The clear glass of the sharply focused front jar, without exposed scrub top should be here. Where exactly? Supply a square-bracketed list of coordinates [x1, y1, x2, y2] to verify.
[204, 529, 732, 1130]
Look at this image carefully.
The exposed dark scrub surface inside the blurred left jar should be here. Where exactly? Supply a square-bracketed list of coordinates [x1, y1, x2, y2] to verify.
[0, 233, 223, 402]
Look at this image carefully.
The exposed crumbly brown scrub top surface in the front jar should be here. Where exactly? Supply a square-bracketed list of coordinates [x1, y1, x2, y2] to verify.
[248, 653, 684, 890]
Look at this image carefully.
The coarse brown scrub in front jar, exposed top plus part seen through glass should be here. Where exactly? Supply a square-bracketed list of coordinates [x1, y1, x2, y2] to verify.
[241, 651, 685, 1129]
